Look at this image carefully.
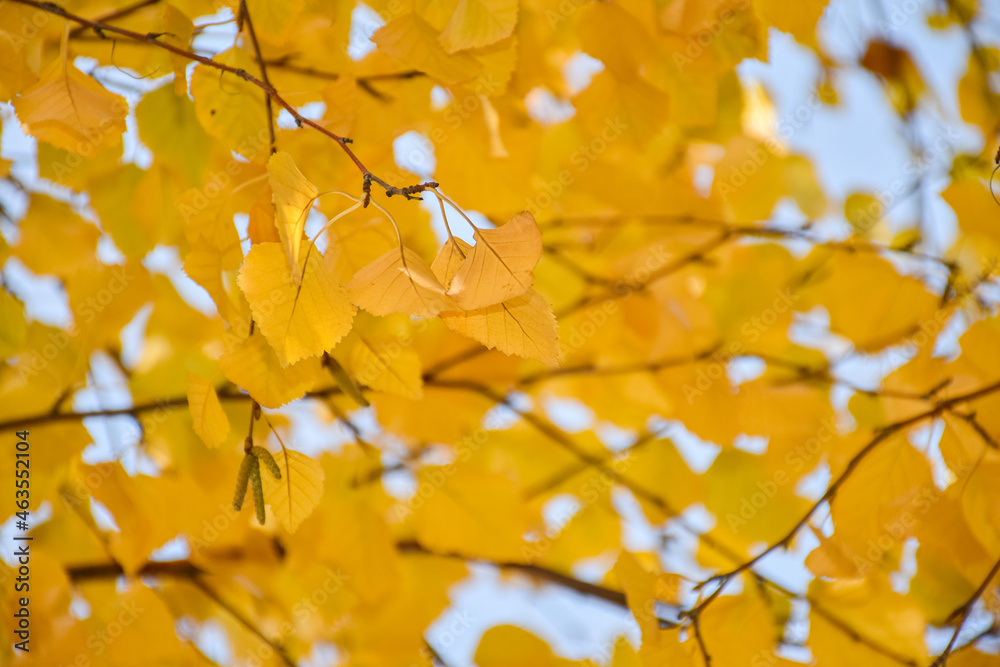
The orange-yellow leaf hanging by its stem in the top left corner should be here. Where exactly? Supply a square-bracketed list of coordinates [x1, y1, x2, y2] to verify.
[14, 58, 128, 155]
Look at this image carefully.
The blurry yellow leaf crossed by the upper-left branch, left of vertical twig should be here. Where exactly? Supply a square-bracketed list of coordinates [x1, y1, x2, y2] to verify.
[191, 47, 269, 161]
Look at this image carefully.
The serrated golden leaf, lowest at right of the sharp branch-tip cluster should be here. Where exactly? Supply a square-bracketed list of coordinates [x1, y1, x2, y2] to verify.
[441, 289, 559, 366]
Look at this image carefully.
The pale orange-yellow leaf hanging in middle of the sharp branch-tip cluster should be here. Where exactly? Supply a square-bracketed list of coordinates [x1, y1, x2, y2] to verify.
[347, 248, 454, 317]
